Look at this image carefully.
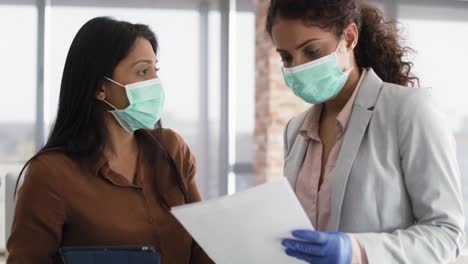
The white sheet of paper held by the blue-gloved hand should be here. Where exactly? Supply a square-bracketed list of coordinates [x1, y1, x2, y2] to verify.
[171, 178, 313, 264]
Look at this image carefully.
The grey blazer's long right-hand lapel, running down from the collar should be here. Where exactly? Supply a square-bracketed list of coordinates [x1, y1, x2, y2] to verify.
[329, 69, 382, 231]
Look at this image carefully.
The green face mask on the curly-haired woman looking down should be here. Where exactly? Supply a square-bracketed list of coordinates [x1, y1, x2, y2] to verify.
[282, 42, 351, 104]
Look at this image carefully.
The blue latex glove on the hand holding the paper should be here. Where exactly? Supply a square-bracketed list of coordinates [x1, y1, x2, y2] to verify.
[281, 230, 353, 264]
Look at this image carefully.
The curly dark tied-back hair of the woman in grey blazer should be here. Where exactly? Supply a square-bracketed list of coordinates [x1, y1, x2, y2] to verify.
[266, 0, 419, 86]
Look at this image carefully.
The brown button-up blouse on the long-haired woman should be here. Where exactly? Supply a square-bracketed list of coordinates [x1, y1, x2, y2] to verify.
[7, 129, 213, 264]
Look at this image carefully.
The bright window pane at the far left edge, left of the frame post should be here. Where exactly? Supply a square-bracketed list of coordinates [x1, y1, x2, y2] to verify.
[0, 0, 37, 251]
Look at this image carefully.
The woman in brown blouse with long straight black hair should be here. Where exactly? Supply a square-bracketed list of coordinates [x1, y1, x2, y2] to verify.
[7, 17, 212, 264]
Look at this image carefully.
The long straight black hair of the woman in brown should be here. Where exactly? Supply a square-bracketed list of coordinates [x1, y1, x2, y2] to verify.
[15, 17, 188, 206]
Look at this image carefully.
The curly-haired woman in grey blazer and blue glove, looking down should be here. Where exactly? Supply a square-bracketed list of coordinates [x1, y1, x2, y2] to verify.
[267, 0, 465, 264]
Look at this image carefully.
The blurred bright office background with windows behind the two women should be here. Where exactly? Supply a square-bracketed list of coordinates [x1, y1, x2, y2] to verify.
[0, 0, 468, 258]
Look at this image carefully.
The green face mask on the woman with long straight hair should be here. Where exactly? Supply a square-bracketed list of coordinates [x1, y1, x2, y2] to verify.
[104, 77, 165, 133]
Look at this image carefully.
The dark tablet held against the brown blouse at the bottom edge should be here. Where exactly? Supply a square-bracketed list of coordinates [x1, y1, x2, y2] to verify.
[59, 246, 161, 264]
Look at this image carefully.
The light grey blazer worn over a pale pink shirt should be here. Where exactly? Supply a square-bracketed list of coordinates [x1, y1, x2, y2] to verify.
[284, 69, 465, 264]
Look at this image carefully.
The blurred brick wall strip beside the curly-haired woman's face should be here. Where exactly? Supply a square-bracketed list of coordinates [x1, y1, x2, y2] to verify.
[254, 0, 307, 184]
